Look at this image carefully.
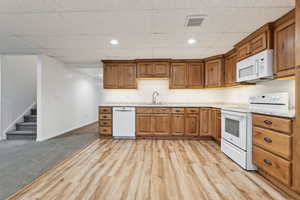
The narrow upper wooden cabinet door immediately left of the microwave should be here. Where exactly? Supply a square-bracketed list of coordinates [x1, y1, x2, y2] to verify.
[225, 54, 237, 86]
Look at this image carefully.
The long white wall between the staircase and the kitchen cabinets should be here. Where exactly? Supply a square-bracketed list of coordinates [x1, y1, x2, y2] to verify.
[37, 55, 100, 141]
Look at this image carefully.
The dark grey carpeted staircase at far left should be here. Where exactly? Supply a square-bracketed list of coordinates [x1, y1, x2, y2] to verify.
[6, 108, 37, 140]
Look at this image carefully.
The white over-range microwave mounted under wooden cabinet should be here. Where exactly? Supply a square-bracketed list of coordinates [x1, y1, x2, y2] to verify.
[236, 49, 273, 82]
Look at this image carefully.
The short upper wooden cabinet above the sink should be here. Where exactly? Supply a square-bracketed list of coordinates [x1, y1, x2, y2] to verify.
[136, 59, 170, 78]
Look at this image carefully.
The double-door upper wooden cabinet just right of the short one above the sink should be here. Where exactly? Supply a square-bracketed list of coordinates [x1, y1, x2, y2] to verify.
[170, 61, 204, 89]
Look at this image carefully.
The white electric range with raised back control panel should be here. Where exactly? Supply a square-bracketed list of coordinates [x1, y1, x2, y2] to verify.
[221, 93, 289, 170]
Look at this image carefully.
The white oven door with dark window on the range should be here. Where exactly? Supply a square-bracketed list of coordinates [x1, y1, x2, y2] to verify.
[222, 110, 247, 151]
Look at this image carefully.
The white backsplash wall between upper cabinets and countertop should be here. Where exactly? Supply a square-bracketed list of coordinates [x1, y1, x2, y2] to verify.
[100, 80, 295, 106]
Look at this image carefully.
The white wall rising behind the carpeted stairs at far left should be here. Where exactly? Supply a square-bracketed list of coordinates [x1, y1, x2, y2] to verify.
[1, 55, 37, 138]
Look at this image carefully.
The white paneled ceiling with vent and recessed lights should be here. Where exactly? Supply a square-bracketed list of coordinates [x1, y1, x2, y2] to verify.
[0, 0, 295, 66]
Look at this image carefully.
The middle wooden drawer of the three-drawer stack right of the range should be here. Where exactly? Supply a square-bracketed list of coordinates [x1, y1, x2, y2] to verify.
[253, 127, 292, 159]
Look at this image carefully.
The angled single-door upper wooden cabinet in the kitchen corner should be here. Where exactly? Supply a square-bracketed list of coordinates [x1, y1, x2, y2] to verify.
[205, 56, 225, 88]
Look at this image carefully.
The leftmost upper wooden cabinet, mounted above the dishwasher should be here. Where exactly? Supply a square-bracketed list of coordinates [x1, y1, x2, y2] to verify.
[103, 61, 137, 89]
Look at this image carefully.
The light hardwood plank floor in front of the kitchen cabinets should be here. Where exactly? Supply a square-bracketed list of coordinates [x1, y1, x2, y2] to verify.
[9, 139, 285, 200]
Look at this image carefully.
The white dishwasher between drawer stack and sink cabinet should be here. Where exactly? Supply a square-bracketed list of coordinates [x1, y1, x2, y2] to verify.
[113, 107, 135, 139]
